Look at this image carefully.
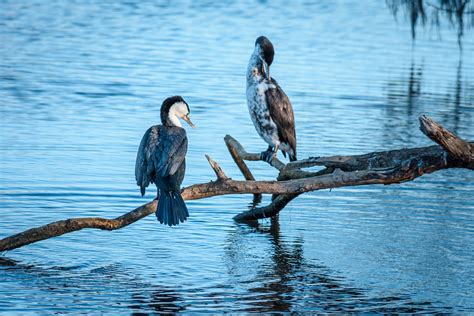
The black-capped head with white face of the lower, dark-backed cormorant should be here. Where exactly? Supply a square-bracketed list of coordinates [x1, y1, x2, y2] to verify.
[160, 95, 196, 128]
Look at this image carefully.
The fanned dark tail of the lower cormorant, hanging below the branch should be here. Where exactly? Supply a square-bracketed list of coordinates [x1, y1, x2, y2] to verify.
[156, 190, 189, 226]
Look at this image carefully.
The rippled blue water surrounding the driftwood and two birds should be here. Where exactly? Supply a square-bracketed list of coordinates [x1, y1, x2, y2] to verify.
[0, 1, 474, 314]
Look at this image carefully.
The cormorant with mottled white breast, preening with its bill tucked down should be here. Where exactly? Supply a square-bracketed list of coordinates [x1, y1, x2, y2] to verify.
[247, 36, 296, 161]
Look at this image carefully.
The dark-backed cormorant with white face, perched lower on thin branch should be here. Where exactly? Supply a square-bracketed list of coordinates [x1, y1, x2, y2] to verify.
[135, 96, 195, 226]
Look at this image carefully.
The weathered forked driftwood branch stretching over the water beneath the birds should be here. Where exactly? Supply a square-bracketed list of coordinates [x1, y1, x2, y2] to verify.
[0, 117, 474, 251]
